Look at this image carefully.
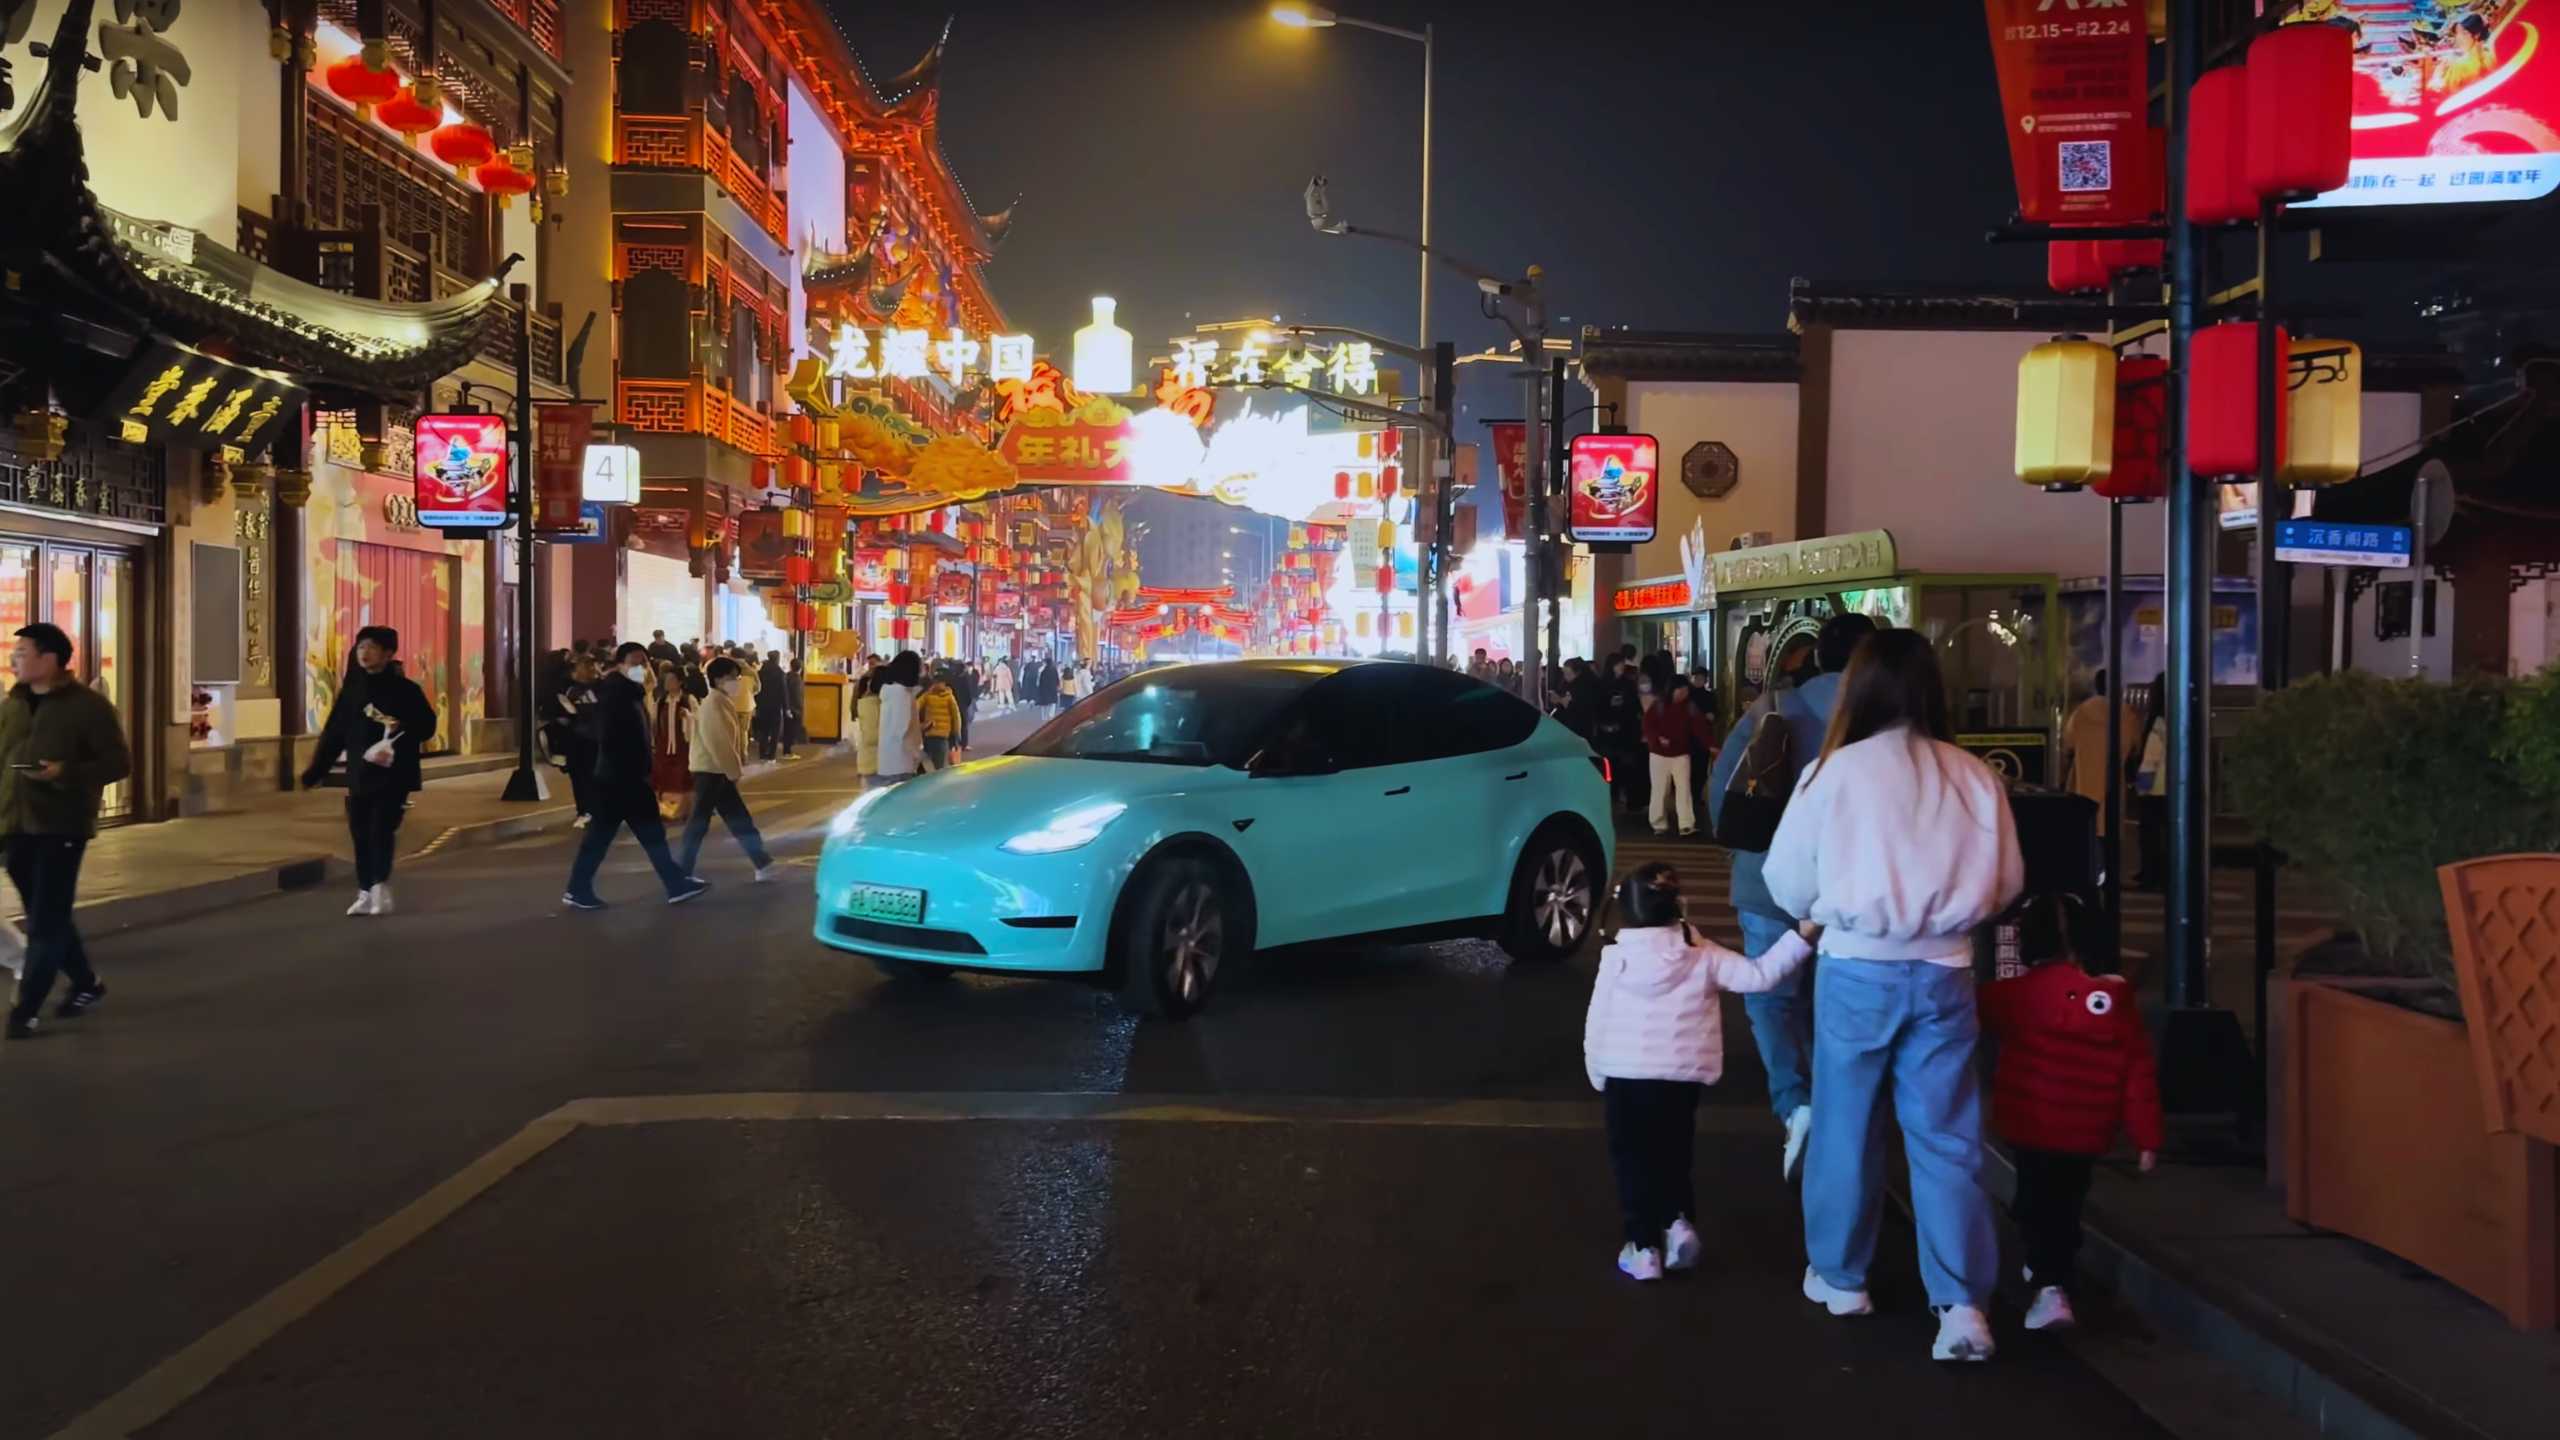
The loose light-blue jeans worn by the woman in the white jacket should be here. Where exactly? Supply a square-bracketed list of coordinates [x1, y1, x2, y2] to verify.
[1805, 956, 1999, 1307]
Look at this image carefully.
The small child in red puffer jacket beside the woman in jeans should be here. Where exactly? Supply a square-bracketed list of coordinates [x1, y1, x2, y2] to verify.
[1981, 899, 2163, 1330]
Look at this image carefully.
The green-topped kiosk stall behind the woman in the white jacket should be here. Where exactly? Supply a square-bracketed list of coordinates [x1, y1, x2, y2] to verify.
[1610, 530, 2066, 784]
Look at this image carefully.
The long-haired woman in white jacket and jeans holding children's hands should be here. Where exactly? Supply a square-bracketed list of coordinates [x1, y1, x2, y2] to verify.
[1764, 630, 2025, 1361]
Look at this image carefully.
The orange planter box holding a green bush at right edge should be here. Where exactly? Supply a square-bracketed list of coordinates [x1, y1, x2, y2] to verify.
[2284, 979, 2560, 1330]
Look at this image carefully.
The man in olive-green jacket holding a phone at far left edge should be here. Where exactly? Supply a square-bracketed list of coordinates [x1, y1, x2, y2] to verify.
[0, 623, 133, 1040]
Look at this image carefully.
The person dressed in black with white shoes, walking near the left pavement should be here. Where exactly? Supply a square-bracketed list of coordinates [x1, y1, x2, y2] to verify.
[302, 625, 435, 915]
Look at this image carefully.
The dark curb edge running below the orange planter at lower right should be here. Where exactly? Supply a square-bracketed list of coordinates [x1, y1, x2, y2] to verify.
[1984, 1145, 2481, 1440]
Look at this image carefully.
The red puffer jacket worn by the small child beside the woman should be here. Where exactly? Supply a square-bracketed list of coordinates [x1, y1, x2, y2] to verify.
[1981, 961, 2163, 1156]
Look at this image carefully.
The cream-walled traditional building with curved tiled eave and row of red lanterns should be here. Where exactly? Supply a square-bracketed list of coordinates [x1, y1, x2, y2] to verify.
[0, 0, 566, 817]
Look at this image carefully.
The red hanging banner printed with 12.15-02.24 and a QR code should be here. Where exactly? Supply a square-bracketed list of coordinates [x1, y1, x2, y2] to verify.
[1984, 0, 2161, 225]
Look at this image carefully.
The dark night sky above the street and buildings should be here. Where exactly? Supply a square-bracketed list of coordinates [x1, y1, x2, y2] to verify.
[837, 0, 2043, 418]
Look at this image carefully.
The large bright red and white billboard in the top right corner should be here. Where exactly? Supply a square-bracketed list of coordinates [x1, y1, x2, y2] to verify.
[2296, 0, 2560, 208]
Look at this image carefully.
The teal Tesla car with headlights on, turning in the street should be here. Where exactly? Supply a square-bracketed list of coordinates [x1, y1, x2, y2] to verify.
[817, 661, 1615, 1017]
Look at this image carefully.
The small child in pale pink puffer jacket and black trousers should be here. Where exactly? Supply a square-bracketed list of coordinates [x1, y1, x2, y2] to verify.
[1582, 863, 1812, 1281]
